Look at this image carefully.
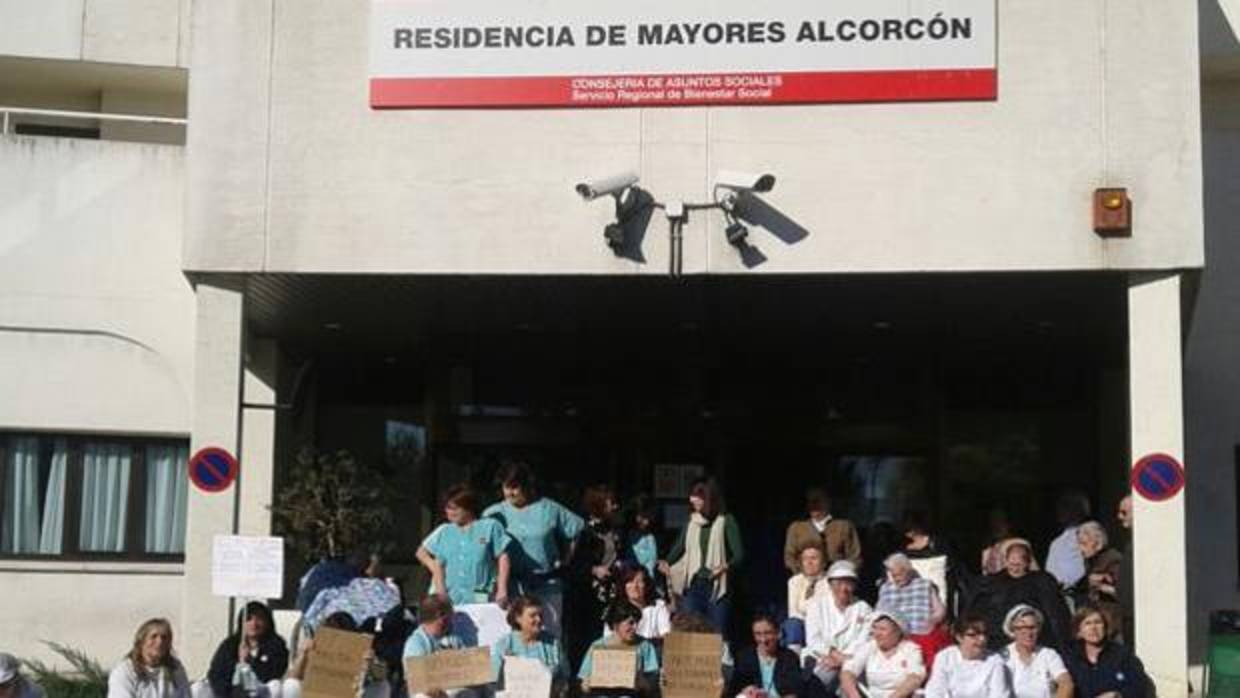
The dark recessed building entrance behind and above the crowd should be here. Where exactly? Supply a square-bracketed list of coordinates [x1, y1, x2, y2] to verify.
[261, 275, 1127, 629]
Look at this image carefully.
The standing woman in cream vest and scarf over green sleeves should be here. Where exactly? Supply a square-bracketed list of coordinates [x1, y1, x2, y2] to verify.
[660, 477, 745, 637]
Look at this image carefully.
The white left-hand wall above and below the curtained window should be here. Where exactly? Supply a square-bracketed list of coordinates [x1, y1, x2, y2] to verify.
[0, 136, 193, 665]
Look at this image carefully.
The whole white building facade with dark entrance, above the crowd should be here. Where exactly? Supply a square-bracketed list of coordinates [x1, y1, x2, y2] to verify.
[0, 0, 1240, 696]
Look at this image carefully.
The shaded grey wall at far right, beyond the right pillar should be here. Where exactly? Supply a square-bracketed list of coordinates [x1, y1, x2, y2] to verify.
[1184, 76, 1240, 661]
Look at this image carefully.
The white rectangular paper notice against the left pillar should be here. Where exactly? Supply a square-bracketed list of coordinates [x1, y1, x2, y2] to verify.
[211, 536, 284, 599]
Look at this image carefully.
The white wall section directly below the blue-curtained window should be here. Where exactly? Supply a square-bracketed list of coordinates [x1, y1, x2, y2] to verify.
[0, 560, 181, 668]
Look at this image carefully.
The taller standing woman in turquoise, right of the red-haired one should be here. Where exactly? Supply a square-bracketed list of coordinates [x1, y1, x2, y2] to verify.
[482, 462, 585, 635]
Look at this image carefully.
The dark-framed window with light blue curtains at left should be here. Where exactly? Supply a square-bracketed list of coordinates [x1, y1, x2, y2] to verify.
[0, 434, 188, 559]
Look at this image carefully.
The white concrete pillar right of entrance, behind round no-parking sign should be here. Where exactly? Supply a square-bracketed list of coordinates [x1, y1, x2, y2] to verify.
[1128, 274, 1188, 698]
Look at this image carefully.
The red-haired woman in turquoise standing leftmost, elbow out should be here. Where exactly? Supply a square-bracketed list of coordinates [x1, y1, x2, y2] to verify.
[417, 485, 512, 605]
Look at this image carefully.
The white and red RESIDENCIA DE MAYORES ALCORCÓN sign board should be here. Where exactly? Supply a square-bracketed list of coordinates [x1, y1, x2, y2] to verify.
[370, 0, 997, 108]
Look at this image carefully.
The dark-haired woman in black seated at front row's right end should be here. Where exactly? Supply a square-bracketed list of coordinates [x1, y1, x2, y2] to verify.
[1064, 606, 1154, 698]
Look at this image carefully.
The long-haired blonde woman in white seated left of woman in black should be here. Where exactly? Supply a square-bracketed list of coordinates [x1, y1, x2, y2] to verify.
[108, 617, 190, 698]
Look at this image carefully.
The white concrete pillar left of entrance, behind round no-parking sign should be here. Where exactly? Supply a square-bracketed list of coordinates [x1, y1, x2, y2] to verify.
[176, 279, 247, 677]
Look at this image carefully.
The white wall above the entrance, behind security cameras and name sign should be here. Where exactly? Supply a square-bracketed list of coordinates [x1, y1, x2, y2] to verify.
[185, 0, 1202, 274]
